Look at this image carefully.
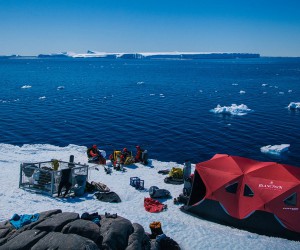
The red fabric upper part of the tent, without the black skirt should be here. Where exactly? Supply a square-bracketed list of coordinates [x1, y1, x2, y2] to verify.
[183, 154, 300, 239]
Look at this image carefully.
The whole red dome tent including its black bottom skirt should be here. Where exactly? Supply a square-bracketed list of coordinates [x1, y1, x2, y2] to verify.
[182, 154, 300, 240]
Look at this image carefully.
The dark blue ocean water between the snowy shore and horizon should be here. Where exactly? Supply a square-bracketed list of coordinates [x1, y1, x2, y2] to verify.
[0, 58, 300, 166]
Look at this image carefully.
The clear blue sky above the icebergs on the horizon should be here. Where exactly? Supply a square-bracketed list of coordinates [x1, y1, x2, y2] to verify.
[0, 0, 300, 56]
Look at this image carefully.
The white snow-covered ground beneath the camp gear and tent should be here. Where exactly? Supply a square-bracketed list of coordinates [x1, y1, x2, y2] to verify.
[0, 144, 300, 250]
